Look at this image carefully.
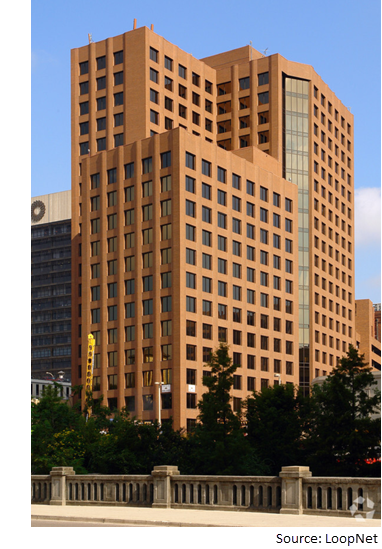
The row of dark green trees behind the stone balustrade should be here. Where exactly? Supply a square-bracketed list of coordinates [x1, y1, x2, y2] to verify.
[32, 344, 381, 476]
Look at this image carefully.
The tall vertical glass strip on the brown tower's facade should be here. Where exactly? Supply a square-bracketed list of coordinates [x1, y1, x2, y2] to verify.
[283, 76, 310, 394]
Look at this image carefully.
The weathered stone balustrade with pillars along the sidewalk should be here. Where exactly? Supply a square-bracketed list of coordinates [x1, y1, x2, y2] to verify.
[32, 465, 381, 518]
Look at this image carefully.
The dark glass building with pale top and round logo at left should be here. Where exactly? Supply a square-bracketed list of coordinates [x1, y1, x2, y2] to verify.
[31, 191, 71, 381]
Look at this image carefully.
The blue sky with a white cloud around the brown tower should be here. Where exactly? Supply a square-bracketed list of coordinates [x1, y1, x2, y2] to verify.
[31, 0, 381, 303]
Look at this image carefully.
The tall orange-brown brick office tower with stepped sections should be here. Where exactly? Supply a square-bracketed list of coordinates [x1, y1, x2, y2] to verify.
[71, 27, 355, 427]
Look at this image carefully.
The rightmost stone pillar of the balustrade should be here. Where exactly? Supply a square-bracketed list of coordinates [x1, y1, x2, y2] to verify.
[279, 465, 312, 515]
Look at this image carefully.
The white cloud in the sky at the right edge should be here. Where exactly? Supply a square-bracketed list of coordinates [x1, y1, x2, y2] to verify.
[355, 187, 381, 247]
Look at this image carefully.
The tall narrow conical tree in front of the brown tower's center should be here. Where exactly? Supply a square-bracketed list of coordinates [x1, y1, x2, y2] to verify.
[186, 343, 267, 475]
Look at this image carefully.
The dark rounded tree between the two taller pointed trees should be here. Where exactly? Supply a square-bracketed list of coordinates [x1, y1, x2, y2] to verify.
[246, 385, 308, 475]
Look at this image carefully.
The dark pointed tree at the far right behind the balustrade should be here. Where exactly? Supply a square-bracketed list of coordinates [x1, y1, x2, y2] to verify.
[306, 345, 381, 476]
